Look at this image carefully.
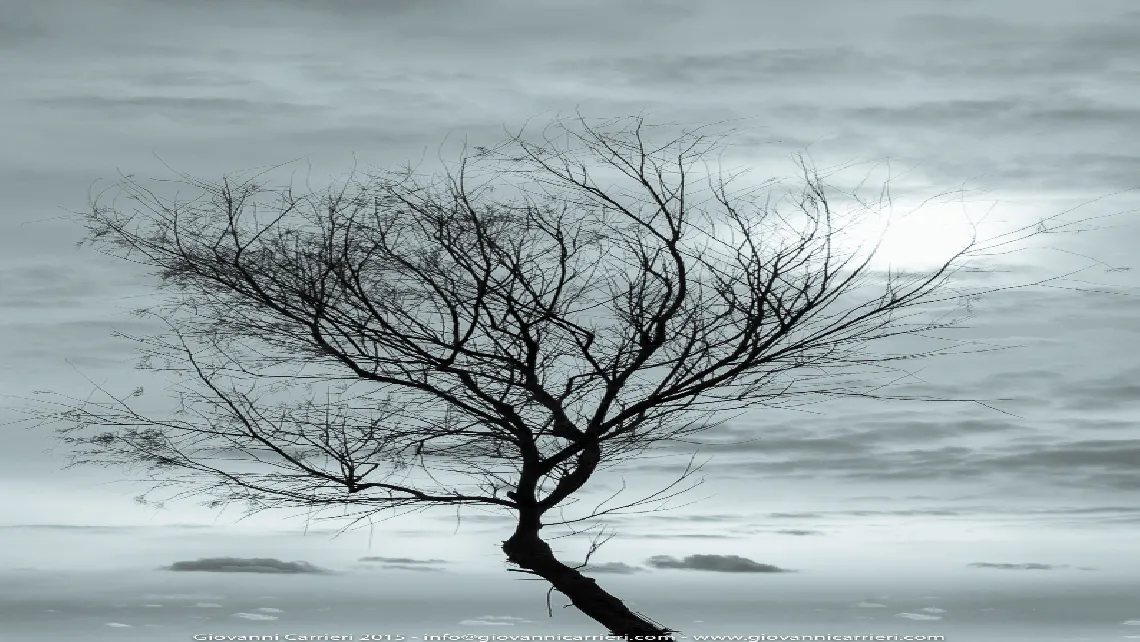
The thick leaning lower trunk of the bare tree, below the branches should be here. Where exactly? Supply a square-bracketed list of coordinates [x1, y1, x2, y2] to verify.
[503, 519, 675, 640]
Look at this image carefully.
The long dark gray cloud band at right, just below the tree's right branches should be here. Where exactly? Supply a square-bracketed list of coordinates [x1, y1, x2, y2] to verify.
[642, 403, 1140, 490]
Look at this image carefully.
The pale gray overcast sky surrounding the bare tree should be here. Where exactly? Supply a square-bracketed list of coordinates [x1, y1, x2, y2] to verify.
[0, 0, 1140, 642]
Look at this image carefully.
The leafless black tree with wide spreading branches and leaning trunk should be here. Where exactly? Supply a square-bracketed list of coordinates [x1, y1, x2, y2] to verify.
[33, 117, 1048, 636]
